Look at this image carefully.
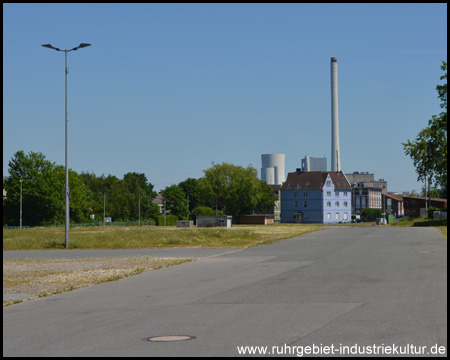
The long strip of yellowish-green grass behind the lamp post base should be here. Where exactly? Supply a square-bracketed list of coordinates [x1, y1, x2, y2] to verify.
[3, 224, 323, 250]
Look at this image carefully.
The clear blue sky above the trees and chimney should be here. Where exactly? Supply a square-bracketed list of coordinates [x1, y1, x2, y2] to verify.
[3, 4, 447, 192]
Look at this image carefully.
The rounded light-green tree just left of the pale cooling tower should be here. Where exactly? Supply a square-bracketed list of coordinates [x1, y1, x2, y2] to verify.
[199, 163, 276, 216]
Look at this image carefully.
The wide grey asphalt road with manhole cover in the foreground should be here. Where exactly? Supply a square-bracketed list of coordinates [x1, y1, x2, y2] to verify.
[3, 227, 447, 357]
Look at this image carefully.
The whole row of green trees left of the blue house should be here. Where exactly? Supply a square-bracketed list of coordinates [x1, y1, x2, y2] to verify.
[3, 151, 276, 226]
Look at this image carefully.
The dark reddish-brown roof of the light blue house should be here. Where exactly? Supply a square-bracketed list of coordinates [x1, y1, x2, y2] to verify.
[280, 171, 351, 191]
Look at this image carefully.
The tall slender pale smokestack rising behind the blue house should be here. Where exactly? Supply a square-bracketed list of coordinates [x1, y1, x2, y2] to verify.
[331, 57, 341, 171]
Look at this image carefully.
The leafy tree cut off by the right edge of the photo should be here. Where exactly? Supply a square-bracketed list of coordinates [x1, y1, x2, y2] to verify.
[402, 61, 447, 195]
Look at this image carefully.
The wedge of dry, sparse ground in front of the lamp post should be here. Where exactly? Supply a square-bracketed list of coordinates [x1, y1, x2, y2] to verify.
[3, 257, 191, 306]
